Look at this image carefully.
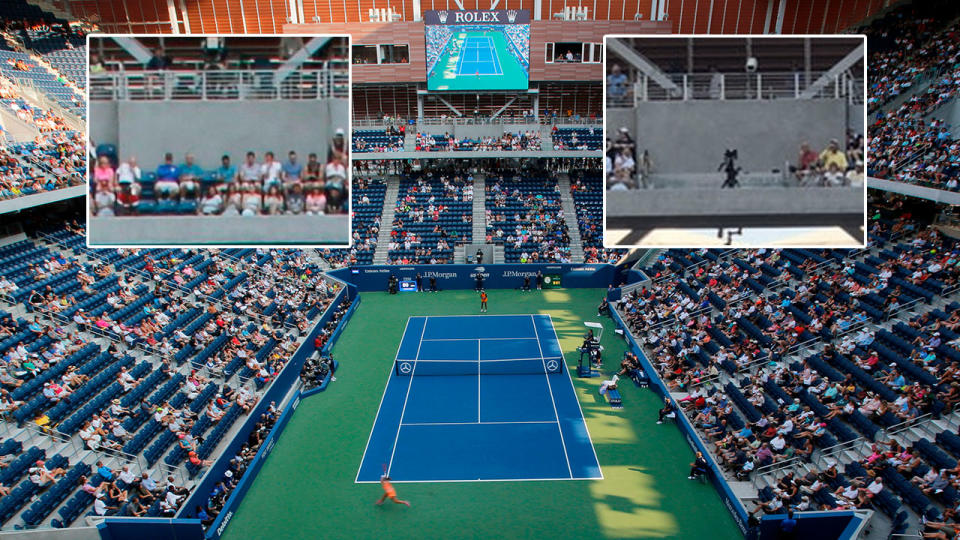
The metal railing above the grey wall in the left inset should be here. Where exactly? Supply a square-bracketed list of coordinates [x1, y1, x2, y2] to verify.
[89, 68, 350, 101]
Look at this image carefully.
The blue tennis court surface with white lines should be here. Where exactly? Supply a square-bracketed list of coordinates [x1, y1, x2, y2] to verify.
[357, 315, 602, 482]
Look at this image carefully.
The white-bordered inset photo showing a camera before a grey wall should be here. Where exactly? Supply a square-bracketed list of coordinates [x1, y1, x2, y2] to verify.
[604, 35, 866, 248]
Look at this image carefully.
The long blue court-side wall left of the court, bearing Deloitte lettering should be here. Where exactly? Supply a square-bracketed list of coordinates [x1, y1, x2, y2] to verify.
[177, 287, 356, 538]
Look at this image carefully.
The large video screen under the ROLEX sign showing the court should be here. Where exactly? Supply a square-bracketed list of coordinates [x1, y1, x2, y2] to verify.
[423, 9, 530, 91]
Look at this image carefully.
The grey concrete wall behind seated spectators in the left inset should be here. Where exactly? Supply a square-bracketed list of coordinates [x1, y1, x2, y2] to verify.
[109, 99, 350, 170]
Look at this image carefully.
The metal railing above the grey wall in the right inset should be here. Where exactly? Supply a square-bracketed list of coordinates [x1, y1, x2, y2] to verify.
[632, 72, 863, 105]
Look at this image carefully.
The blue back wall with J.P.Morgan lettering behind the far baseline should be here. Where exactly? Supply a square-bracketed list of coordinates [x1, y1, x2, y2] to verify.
[329, 264, 617, 292]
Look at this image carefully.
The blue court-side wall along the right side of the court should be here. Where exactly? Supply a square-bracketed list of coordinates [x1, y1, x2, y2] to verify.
[610, 310, 860, 540]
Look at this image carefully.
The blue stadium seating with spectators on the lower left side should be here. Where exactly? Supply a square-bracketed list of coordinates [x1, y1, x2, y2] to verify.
[0, 221, 348, 528]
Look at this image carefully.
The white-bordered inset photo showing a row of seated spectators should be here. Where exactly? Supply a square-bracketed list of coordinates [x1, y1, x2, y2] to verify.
[87, 35, 350, 247]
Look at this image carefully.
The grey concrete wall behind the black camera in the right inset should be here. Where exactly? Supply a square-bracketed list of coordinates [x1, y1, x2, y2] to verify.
[607, 100, 847, 173]
